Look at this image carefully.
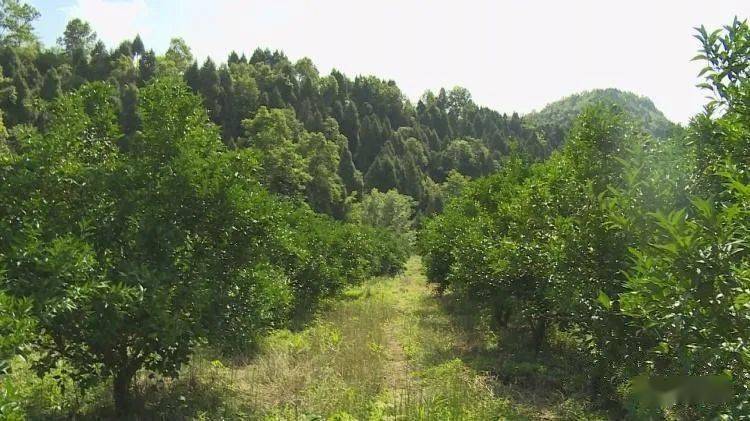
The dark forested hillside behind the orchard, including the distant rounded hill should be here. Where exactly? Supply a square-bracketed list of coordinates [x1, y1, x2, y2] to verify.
[0, 19, 673, 213]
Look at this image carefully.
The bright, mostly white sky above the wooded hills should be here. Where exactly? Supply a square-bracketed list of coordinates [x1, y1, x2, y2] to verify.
[29, 0, 750, 123]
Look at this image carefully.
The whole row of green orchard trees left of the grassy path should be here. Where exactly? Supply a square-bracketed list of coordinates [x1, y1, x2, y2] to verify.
[0, 77, 407, 416]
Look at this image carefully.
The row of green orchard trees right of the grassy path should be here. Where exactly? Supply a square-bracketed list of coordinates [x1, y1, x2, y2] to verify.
[420, 21, 750, 419]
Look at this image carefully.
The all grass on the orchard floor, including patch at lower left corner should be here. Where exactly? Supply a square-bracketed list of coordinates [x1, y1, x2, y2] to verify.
[10, 258, 597, 421]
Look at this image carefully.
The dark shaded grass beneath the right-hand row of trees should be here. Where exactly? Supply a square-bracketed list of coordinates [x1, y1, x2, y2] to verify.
[415, 293, 623, 419]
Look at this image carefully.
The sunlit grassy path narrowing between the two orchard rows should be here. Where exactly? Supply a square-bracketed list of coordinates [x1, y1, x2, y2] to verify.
[164, 258, 595, 420]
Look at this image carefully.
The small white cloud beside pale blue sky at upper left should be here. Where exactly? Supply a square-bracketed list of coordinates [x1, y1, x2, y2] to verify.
[64, 0, 151, 45]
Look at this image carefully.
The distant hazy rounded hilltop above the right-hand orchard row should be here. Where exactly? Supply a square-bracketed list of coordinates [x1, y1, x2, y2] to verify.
[525, 88, 679, 148]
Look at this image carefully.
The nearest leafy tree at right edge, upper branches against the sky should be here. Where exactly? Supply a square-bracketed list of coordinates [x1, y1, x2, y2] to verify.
[613, 20, 750, 412]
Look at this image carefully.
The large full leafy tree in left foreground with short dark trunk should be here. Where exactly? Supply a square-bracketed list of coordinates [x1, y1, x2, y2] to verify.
[0, 80, 368, 415]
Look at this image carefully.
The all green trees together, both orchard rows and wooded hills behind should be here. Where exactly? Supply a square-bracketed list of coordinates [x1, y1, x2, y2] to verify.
[0, 0, 750, 420]
